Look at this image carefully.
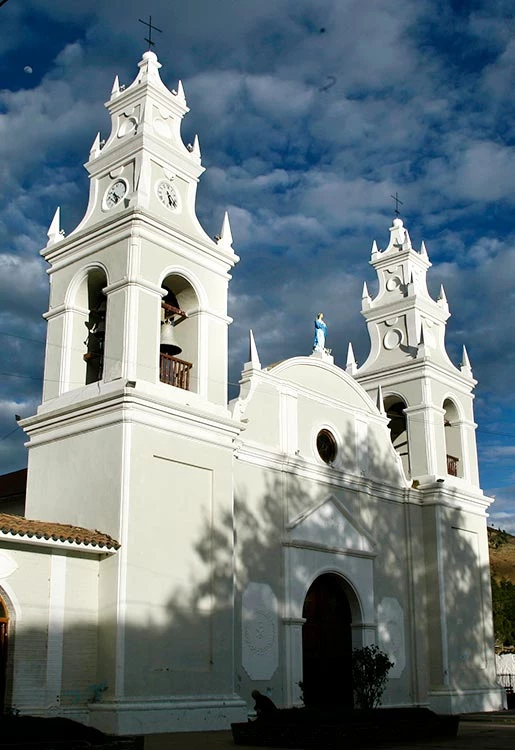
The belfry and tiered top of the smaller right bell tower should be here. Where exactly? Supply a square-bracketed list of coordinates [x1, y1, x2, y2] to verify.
[354, 217, 479, 488]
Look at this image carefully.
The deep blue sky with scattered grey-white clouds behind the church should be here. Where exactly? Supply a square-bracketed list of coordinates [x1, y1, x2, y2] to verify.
[0, 0, 515, 531]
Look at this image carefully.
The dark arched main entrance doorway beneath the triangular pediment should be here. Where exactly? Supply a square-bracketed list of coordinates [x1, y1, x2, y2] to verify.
[302, 573, 353, 709]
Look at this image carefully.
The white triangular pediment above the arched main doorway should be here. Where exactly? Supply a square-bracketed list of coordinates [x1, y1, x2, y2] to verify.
[287, 495, 375, 555]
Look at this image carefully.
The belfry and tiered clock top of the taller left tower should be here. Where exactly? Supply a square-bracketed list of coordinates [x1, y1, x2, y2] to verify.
[37, 51, 238, 405]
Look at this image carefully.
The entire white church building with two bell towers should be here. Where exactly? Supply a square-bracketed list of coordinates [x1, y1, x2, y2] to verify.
[0, 51, 503, 734]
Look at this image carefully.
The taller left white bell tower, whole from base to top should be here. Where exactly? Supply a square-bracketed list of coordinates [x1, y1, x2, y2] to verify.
[22, 51, 244, 733]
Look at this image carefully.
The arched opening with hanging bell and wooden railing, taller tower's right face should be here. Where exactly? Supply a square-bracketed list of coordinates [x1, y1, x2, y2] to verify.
[159, 274, 199, 391]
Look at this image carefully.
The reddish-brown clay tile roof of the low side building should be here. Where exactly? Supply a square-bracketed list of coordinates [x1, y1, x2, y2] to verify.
[0, 513, 120, 550]
